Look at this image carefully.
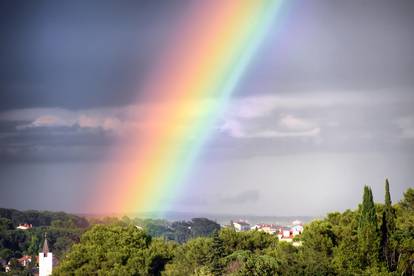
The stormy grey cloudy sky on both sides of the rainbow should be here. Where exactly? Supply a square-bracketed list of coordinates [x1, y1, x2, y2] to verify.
[0, 0, 414, 216]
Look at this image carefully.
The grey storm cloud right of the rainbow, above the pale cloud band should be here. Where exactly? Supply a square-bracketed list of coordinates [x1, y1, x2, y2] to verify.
[237, 0, 414, 95]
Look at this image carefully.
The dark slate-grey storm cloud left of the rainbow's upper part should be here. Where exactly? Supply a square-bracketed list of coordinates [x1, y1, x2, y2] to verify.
[0, 1, 186, 110]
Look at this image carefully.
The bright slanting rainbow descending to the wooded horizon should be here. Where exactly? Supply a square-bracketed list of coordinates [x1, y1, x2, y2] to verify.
[90, 0, 282, 216]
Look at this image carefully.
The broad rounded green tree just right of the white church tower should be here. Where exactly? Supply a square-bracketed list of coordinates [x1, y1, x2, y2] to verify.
[54, 225, 172, 275]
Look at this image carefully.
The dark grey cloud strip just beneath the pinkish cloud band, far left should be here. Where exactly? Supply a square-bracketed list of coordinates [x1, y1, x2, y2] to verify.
[0, 121, 113, 164]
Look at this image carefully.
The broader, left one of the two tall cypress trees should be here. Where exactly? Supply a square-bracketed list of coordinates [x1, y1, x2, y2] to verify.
[358, 186, 379, 267]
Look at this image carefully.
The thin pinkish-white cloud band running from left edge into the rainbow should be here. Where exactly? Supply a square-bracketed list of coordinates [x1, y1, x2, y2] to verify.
[0, 99, 220, 136]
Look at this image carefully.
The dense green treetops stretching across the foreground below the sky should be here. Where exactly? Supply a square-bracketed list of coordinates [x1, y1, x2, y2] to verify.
[0, 181, 414, 275]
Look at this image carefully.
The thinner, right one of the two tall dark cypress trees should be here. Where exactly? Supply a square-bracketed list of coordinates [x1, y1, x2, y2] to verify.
[381, 179, 395, 271]
